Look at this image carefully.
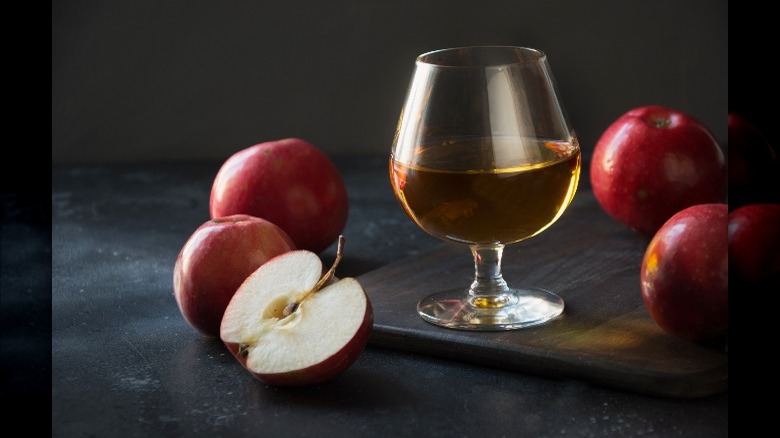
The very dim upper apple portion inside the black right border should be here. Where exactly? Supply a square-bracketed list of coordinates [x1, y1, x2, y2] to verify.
[728, 111, 780, 210]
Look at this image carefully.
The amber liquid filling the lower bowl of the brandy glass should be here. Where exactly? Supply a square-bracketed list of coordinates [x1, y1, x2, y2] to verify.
[390, 139, 582, 244]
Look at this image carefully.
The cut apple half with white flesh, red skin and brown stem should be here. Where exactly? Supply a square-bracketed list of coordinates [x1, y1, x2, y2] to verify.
[220, 240, 374, 386]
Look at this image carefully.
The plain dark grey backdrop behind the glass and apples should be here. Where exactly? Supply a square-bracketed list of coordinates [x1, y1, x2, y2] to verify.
[52, 0, 729, 165]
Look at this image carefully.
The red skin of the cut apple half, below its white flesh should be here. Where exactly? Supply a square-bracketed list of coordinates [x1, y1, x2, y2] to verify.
[224, 300, 374, 386]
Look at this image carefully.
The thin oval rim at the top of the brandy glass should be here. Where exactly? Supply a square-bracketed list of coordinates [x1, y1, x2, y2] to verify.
[415, 45, 547, 68]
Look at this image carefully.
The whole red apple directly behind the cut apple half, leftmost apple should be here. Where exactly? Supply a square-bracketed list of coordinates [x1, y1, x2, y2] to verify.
[173, 214, 296, 337]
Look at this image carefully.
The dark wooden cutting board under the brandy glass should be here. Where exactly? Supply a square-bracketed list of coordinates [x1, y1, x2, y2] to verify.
[358, 188, 728, 398]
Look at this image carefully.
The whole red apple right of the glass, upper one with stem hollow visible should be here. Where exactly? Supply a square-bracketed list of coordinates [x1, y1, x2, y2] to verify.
[590, 105, 727, 237]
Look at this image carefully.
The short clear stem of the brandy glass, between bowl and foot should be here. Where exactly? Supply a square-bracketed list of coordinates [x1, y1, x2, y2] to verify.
[469, 244, 509, 307]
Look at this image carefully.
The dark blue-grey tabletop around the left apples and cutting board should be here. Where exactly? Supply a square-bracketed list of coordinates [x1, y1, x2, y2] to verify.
[42, 156, 728, 437]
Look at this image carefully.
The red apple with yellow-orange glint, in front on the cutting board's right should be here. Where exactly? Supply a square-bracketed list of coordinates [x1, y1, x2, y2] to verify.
[640, 203, 729, 341]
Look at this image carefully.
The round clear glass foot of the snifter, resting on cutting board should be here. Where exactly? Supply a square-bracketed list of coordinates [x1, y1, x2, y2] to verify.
[417, 288, 564, 331]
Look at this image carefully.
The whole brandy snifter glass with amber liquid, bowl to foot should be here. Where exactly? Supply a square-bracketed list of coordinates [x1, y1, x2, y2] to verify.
[389, 46, 582, 330]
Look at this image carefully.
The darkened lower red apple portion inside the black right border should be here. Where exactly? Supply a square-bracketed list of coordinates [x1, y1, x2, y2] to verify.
[728, 203, 780, 293]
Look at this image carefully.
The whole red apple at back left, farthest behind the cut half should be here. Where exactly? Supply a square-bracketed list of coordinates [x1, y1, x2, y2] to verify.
[209, 138, 349, 253]
